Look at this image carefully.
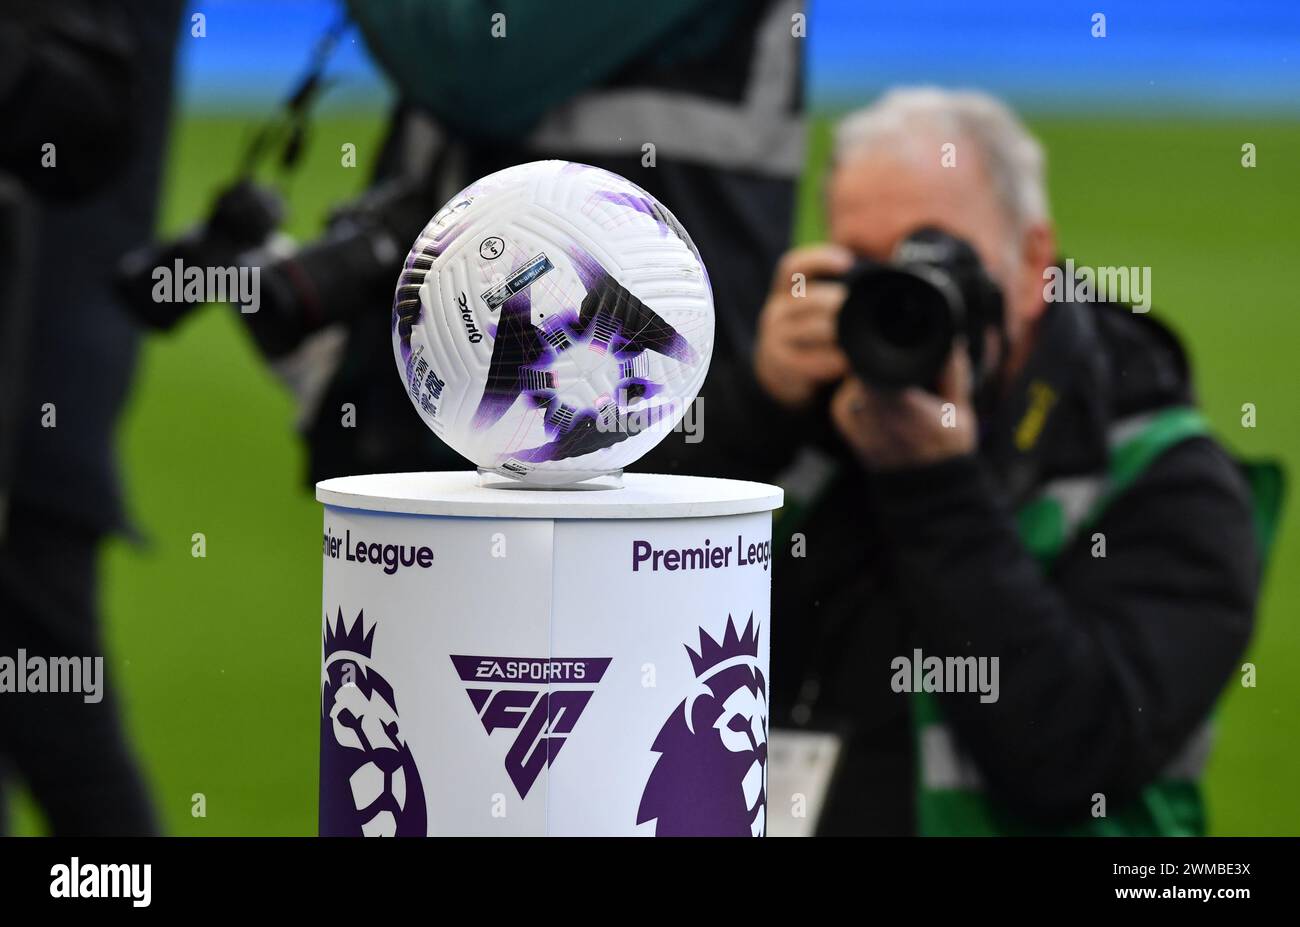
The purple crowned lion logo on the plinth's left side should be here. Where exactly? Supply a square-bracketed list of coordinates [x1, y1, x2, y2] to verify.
[320, 608, 428, 837]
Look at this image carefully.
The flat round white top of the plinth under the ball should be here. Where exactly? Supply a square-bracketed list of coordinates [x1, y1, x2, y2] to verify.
[316, 471, 783, 519]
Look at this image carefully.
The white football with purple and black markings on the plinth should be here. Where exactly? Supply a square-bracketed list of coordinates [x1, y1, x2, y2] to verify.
[393, 161, 714, 485]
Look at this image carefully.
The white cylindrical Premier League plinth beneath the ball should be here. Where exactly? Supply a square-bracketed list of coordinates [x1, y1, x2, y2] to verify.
[316, 473, 781, 835]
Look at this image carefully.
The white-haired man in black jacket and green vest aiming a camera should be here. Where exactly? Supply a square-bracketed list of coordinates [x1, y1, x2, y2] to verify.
[702, 90, 1258, 835]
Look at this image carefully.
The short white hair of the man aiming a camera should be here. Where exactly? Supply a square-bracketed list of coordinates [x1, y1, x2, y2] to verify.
[835, 87, 1048, 231]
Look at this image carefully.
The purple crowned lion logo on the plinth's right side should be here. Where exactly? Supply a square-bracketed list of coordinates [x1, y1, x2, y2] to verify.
[637, 615, 767, 837]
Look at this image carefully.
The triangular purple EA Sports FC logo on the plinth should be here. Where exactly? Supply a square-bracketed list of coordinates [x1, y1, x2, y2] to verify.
[450, 654, 610, 798]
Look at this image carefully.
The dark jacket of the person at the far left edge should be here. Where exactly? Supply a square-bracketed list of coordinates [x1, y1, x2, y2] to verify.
[0, 0, 182, 533]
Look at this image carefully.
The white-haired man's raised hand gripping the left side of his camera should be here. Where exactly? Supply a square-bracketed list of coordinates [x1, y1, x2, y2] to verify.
[754, 244, 853, 410]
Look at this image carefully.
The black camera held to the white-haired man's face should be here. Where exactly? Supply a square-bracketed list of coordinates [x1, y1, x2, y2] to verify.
[839, 228, 1005, 389]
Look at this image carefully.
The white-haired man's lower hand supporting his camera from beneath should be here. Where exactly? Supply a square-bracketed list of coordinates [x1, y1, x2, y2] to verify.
[831, 345, 979, 471]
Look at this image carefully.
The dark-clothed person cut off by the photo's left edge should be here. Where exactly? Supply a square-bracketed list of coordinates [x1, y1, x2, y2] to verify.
[0, 0, 181, 836]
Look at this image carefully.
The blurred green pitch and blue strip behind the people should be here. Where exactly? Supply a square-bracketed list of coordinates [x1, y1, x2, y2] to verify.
[18, 0, 1300, 835]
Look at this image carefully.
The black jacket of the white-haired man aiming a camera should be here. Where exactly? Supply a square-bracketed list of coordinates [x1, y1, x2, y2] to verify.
[638, 303, 1258, 833]
